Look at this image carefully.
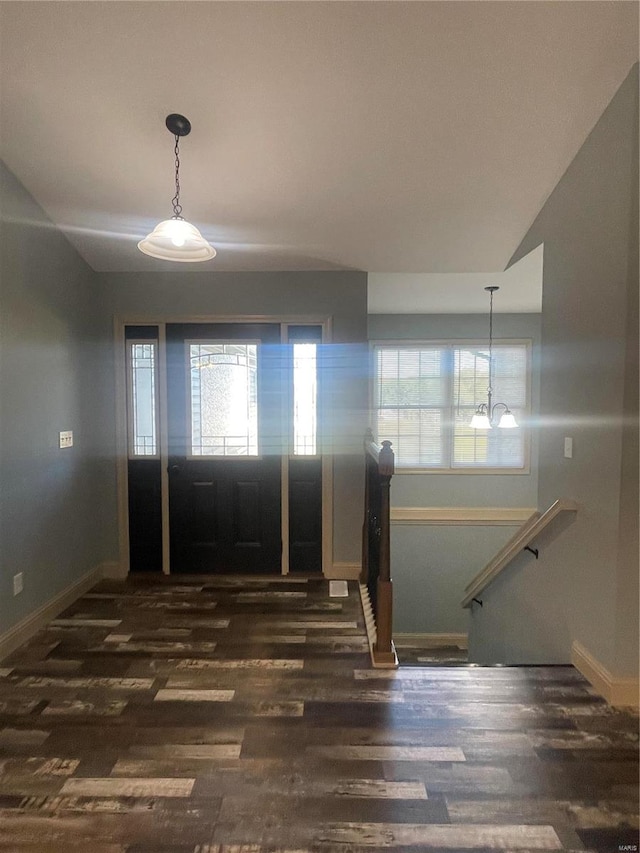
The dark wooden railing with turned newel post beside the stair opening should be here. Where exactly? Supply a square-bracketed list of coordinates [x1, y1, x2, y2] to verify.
[360, 430, 397, 667]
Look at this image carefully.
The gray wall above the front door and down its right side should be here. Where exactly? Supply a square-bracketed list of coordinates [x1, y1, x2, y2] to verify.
[100, 271, 368, 562]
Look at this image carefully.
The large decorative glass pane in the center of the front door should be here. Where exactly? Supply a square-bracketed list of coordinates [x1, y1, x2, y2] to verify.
[189, 342, 258, 456]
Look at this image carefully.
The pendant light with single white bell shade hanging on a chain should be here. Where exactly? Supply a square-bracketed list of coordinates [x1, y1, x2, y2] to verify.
[138, 113, 216, 263]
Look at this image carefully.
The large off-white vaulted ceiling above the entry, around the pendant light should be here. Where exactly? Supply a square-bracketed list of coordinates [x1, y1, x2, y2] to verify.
[0, 0, 638, 283]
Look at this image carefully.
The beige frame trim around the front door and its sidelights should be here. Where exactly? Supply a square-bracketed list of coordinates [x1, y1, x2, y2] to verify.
[113, 314, 333, 577]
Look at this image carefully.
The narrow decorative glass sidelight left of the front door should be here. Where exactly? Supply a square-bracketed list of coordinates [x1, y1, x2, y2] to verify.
[129, 341, 158, 456]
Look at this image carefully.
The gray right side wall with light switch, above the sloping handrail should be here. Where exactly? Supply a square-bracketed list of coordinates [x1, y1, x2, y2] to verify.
[471, 65, 638, 675]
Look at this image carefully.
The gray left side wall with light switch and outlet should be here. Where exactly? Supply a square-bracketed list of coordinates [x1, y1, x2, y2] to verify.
[0, 163, 115, 633]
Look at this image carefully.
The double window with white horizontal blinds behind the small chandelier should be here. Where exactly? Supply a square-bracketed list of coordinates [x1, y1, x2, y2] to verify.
[374, 342, 529, 471]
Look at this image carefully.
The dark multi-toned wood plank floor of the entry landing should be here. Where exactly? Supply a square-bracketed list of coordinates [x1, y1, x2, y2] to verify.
[0, 577, 638, 853]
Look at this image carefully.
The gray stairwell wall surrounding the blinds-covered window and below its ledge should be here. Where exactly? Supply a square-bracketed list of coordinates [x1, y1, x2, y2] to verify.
[369, 312, 540, 634]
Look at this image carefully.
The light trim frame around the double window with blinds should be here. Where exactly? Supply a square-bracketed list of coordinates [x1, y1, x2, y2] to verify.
[369, 337, 533, 477]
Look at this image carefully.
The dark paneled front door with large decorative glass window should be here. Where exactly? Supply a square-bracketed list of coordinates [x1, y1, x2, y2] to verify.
[167, 323, 283, 573]
